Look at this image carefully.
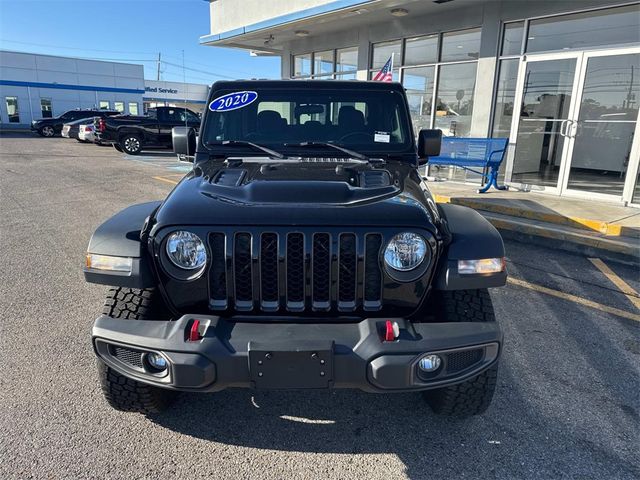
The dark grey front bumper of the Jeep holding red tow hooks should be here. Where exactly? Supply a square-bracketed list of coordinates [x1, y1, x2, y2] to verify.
[92, 315, 502, 392]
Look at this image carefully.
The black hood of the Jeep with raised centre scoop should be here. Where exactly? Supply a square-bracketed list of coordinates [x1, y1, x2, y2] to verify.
[155, 158, 437, 234]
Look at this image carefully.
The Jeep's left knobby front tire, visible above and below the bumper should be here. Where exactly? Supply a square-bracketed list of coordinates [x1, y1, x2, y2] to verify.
[98, 287, 177, 414]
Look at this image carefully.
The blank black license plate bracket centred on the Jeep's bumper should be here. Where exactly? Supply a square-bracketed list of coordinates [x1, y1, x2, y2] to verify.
[248, 341, 333, 390]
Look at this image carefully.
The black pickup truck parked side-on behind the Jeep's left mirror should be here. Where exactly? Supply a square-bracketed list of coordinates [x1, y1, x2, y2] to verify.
[95, 107, 200, 155]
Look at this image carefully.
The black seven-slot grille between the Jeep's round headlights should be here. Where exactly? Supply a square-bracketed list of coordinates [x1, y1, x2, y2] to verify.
[208, 230, 383, 312]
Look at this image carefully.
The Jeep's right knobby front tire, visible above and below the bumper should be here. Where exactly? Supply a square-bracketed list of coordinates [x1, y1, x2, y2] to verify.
[424, 289, 498, 417]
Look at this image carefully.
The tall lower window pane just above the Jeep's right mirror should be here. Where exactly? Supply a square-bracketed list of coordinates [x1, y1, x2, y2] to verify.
[402, 66, 435, 133]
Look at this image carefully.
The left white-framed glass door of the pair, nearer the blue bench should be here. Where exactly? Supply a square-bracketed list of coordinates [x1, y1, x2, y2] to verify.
[507, 52, 581, 193]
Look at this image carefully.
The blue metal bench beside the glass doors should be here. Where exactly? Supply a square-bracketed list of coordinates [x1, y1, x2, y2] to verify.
[429, 137, 509, 193]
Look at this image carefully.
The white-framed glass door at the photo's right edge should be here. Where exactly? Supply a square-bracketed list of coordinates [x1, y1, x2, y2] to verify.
[562, 48, 640, 201]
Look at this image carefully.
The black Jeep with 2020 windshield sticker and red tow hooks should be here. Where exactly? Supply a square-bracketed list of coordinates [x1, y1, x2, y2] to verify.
[84, 81, 507, 416]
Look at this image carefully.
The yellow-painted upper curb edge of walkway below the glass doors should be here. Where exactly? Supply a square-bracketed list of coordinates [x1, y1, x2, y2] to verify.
[434, 194, 633, 237]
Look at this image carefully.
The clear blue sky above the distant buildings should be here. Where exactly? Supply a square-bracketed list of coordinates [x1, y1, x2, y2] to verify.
[0, 0, 280, 84]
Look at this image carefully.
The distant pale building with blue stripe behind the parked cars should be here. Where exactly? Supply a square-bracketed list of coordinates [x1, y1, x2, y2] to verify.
[0, 50, 209, 125]
